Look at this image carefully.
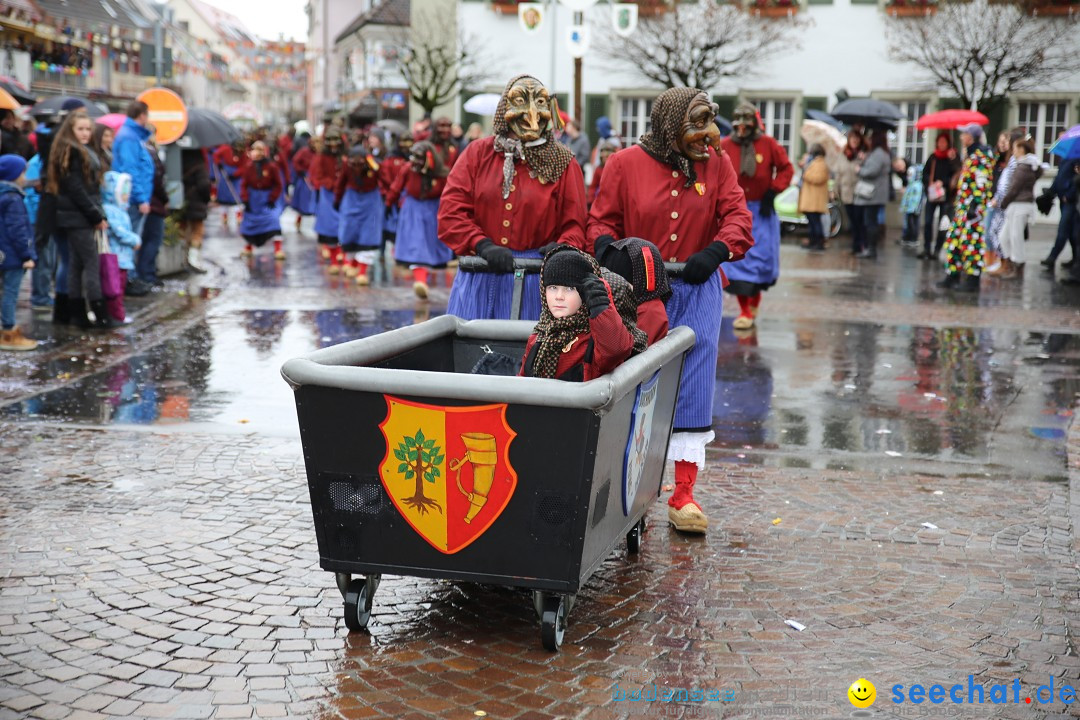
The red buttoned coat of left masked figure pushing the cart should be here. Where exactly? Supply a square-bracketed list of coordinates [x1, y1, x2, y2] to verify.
[438, 137, 585, 255]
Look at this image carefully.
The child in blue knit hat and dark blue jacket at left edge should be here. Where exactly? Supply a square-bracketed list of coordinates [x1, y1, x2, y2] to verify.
[0, 154, 38, 350]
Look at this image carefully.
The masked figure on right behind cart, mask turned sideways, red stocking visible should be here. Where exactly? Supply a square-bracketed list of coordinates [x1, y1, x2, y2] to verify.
[589, 87, 754, 532]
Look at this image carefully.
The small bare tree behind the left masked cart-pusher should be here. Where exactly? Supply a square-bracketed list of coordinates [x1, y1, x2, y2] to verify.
[399, 14, 488, 112]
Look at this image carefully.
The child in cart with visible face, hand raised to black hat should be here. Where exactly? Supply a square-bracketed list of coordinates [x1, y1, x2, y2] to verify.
[518, 245, 647, 382]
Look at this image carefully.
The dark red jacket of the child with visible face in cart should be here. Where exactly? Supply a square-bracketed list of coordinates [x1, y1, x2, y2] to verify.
[517, 289, 634, 382]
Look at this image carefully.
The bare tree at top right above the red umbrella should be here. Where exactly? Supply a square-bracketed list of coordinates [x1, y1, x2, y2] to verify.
[886, 0, 1080, 109]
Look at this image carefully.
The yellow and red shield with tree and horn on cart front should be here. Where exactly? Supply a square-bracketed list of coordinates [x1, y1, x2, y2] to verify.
[379, 395, 517, 555]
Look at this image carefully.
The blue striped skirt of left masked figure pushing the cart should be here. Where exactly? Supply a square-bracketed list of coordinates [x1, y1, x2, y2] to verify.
[446, 250, 544, 323]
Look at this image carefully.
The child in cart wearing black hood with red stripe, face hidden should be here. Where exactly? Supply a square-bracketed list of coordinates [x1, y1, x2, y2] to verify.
[600, 237, 672, 345]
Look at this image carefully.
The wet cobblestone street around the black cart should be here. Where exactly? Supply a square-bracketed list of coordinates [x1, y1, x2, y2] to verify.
[0, 215, 1080, 720]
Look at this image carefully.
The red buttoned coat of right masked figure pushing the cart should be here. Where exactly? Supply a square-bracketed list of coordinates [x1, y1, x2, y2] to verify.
[589, 146, 754, 267]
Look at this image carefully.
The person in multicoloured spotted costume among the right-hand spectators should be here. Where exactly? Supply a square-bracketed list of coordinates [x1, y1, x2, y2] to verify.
[939, 123, 994, 293]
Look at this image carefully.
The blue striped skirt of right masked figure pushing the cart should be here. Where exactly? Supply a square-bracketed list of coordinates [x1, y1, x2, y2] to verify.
[667, 273, 724, 430]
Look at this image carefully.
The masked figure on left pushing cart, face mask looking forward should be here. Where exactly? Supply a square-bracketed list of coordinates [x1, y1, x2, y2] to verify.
[438, 76, 585, 321]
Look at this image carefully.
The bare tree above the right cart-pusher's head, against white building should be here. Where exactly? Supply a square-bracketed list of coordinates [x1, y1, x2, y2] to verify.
[596, 0, 810, 90]
